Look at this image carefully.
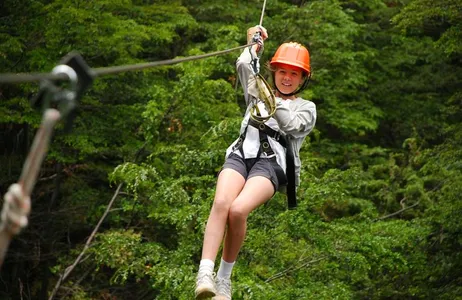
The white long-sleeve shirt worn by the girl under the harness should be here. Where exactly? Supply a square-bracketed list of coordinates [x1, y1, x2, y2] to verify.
[226, 48, 316, 185]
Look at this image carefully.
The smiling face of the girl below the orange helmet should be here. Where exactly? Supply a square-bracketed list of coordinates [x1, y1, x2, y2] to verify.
[274, 64, 303, 99]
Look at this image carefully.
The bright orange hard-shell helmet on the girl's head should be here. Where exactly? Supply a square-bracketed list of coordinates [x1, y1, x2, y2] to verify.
[270, 42, 311, 74]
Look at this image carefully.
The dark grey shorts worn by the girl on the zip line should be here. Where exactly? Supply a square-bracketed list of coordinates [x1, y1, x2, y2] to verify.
[222, 153, 287, 192]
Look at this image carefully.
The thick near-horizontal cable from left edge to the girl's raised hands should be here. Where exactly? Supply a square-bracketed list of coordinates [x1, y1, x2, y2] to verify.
[0, 43, 256, 83]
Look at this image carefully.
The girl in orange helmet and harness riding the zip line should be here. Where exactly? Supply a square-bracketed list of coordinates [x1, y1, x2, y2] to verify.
[195, 26, 316, 300]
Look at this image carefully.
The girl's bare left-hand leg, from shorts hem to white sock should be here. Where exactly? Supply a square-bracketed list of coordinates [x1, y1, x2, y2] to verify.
[202, 169, 245, 261]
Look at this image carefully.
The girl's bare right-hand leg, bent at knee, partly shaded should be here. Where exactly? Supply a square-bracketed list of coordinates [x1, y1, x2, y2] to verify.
[223, 176, 274, 262]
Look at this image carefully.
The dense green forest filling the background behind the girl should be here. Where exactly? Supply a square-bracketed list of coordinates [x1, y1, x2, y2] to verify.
[0, 0, 462, 300]
